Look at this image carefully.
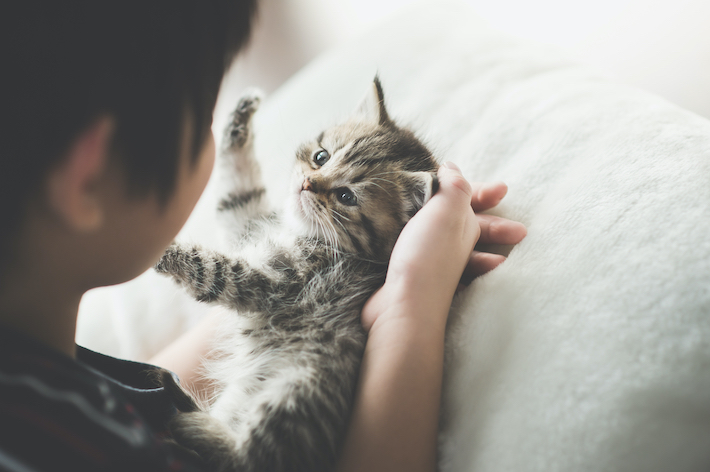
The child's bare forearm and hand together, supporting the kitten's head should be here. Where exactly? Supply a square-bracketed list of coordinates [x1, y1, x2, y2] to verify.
[338, 165, 526, 472]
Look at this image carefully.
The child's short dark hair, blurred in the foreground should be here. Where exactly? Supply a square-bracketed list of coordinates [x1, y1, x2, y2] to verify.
[0, 0, 256, 273]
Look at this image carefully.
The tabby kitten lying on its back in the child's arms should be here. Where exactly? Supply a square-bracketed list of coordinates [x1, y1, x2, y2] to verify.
[156, 78, 438, 472]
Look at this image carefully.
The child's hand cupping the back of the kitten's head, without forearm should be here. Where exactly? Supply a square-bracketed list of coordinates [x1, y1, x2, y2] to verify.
[362, 163, 526, 331]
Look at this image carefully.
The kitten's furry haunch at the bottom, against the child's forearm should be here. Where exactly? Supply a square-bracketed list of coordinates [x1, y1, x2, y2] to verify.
[225, 364, 357, 472]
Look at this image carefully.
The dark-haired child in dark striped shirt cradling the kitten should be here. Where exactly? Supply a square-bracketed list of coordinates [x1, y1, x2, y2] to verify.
[0, 0, 525, 471]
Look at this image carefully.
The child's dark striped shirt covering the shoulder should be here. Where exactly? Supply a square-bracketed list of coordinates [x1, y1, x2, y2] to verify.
[0, 328, 204, 471]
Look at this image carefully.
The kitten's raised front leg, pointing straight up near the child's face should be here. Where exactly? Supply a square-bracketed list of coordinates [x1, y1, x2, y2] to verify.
[217, 90, 271, 241]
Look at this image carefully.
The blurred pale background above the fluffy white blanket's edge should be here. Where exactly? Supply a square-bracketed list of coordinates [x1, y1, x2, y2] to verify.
[222, 0, 710, 118]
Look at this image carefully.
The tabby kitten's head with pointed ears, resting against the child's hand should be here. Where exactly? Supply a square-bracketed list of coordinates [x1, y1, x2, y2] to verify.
[289, 78, 438, 262]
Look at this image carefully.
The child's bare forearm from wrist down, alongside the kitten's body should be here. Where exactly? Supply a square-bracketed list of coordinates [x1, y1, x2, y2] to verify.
[338, 307, 445, 472]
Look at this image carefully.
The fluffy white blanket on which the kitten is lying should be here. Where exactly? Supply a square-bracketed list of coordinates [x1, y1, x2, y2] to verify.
[79, 2, 710, 472]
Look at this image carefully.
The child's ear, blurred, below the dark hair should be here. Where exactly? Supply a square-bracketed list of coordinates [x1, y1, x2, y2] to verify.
[47, 116, 114, 232]
